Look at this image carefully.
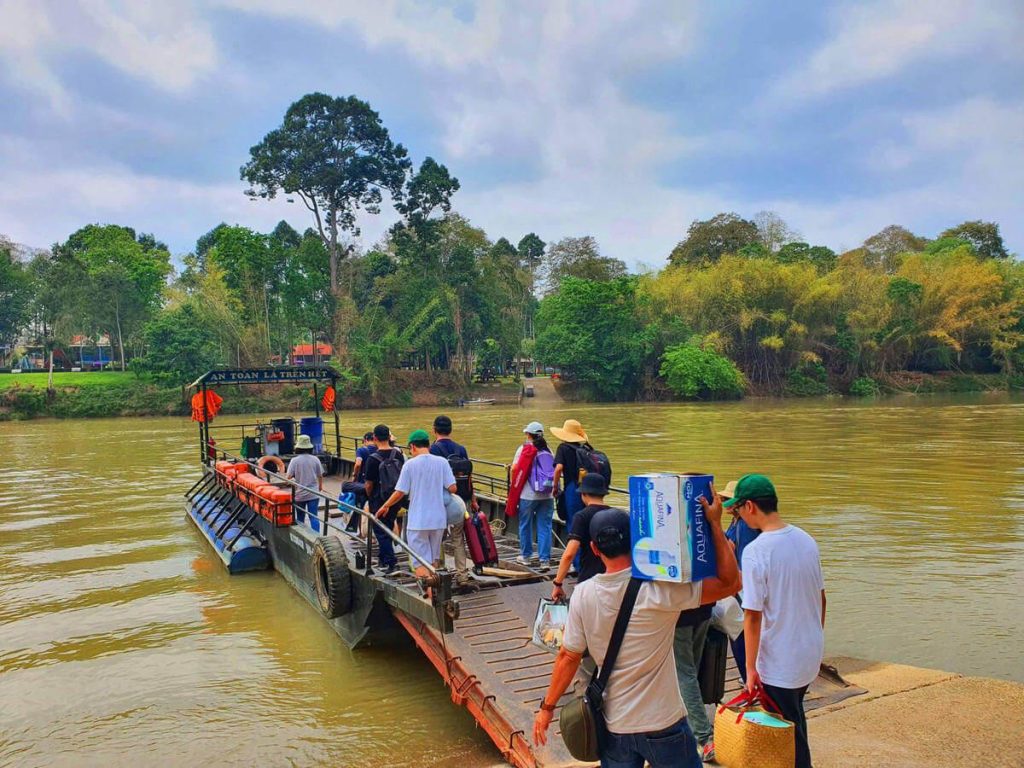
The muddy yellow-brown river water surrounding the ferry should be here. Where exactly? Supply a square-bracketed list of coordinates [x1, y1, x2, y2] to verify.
[0, 392, 1024, 768]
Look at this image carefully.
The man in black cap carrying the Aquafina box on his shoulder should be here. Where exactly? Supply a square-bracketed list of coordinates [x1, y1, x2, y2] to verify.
[534, 500, 739, 768]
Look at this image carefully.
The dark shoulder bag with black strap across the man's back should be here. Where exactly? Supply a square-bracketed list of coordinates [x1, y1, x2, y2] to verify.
[558, 578, 642, 763]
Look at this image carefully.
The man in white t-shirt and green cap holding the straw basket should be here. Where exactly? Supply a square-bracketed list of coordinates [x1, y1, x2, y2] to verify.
[725, 474, 825, 768]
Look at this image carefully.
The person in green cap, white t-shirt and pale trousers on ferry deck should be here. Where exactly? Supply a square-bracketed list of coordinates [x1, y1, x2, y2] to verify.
[377, 429, 457, 583]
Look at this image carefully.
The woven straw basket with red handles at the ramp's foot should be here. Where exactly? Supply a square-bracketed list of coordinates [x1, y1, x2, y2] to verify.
[715, 694, 797, 768]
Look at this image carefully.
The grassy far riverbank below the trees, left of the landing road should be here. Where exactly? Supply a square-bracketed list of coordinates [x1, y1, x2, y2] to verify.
[0, 371, 519, 421]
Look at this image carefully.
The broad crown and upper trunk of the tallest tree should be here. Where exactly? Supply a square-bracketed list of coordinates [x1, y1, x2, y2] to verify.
[241, 93, 410, 296]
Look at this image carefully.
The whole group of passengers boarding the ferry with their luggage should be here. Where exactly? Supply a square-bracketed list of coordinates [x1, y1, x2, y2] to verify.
[288, 416, 825, 768]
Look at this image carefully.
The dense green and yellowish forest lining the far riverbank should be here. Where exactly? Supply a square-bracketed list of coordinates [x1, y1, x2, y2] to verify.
[0, 94, 1024, 400]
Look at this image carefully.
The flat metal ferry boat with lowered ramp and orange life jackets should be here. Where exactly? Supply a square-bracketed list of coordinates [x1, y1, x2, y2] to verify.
[185, 368, 859, 768]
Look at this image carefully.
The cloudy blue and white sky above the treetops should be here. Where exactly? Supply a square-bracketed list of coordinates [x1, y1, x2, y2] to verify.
[0, 0, 1024, 265]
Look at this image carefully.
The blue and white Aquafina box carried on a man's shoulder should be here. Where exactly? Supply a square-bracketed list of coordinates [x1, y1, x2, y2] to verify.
[630, 474, 717, 582]
